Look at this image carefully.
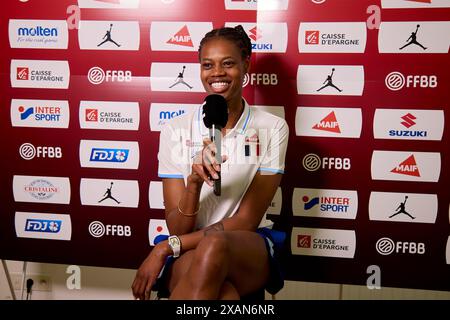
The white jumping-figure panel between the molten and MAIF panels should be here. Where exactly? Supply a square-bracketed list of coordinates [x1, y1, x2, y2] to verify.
[78, 20, 140, 51]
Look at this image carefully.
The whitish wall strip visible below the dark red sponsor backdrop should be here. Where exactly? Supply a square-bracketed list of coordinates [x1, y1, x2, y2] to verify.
[0, 261, 450, 300]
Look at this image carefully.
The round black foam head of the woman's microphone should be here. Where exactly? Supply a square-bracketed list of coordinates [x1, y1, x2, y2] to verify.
[203, 94, 228, 128]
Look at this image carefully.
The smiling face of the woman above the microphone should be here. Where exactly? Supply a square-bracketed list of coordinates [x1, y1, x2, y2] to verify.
[200, 38, 249, 105]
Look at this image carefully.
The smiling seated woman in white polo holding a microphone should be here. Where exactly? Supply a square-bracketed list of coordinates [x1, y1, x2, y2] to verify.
[132, 26, 288, 299]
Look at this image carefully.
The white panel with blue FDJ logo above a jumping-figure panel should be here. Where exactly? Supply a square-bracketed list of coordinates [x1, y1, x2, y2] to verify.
[80, 140, 139, 169]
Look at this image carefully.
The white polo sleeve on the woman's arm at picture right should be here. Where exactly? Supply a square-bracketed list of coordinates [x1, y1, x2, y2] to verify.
[258, 118, 289, 174]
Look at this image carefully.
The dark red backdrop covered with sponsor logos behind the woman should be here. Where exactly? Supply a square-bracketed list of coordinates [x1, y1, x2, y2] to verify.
[0, 0, 450, 290]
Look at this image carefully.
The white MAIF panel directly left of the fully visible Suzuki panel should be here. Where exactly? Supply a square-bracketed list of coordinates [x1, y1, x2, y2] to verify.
[295, 107, 362, 138]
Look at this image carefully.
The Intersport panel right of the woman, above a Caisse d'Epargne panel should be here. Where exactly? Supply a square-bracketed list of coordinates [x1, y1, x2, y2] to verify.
[292, 188, 358, 219]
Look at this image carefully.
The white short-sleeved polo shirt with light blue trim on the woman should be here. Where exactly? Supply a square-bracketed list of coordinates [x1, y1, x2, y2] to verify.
[158, 101, 289, 229]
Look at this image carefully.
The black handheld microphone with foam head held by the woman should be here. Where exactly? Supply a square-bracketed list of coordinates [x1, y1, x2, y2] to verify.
[203, 94, 228, 196]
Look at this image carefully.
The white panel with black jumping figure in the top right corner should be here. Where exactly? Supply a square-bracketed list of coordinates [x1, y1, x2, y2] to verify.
[378, 21, 450, 53]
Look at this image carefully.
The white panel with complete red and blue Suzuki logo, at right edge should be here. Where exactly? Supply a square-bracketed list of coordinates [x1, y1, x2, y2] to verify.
[373, 109, 444, 141]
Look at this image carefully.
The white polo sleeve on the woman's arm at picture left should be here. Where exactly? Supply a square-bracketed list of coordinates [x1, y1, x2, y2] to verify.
[158, 124, 183, 179]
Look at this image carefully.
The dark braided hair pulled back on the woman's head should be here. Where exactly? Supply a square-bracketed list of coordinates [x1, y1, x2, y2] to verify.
[198, 25, 252, 59]
